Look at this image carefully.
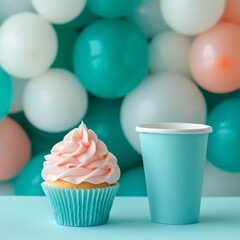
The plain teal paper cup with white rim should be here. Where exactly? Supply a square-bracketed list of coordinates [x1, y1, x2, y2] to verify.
[136, 123, 212, 224]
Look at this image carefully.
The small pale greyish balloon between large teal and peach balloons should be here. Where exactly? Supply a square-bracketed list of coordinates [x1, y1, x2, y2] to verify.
[149, 31, 192, 76]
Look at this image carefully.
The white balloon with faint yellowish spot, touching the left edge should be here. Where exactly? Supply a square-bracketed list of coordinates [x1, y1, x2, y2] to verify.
[0, 13, 58, 78]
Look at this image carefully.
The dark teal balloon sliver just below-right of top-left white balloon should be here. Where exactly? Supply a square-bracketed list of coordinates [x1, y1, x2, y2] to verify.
[63, 6, 98, 29]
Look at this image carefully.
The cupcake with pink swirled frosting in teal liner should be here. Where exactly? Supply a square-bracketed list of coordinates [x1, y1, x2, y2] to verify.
[42, 122, 120, 226]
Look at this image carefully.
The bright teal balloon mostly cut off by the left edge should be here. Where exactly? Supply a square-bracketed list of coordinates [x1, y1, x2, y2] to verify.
[0, 68, 12, 120]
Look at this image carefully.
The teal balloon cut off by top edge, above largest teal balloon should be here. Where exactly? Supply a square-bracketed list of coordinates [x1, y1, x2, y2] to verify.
[87, 0, 141, 18]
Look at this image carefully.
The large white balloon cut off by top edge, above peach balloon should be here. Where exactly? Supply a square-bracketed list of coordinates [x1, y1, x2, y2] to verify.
[161, 0, 225, 35]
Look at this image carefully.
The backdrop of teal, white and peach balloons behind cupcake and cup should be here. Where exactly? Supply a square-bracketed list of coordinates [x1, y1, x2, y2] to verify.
[0, 0, 240, 195]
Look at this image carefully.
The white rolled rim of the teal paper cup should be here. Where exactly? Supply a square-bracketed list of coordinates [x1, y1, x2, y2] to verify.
[136, 122, 213, 134]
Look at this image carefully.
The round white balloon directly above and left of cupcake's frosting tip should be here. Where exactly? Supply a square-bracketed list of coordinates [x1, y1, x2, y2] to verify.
[23, 69, 88, 132]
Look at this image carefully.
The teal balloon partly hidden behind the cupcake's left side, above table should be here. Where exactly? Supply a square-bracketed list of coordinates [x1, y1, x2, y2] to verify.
[14, 153, 47, 196]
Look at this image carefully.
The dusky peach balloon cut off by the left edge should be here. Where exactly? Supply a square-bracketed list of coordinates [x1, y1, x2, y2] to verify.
[0, 117, 31, 181]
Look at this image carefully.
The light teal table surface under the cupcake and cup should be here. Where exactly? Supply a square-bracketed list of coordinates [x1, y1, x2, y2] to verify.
[0, 196, 240, 240]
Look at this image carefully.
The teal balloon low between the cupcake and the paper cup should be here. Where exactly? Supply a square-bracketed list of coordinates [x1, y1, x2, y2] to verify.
[118, 166, 147, 196]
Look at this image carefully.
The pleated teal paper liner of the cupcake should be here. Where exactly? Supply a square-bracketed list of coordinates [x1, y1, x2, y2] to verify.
[42, 183, 119, 227]
